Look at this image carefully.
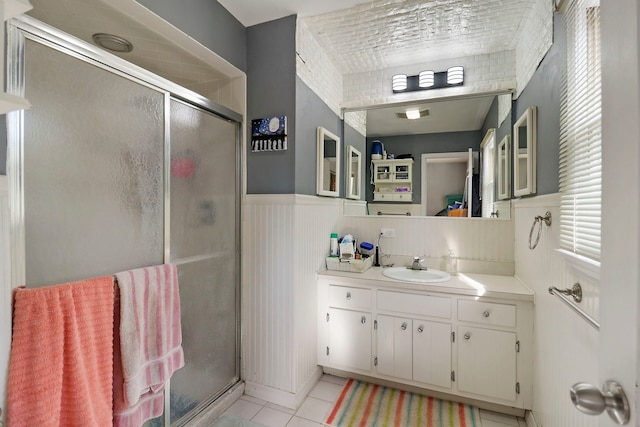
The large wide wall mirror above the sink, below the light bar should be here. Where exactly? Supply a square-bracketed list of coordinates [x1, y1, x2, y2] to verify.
[344, 91, 513, 219]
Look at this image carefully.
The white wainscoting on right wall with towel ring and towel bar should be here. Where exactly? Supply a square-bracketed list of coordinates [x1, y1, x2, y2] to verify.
[514, 194, 599, 427]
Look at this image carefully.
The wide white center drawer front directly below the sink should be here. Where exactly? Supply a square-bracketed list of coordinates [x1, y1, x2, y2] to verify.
[378, 291, 451, 319]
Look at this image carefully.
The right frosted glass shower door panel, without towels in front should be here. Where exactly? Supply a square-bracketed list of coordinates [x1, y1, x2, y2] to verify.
[170, 100, 238, 422]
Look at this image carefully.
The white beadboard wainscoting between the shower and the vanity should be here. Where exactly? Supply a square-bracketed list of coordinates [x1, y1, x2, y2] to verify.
[242, 195, 342, 408]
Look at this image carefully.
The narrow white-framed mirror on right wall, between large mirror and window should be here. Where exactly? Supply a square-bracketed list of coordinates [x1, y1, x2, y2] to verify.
[513, 106, 536, 197]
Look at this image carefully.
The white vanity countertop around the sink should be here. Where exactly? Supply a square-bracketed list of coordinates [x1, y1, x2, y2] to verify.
[318, 267, 534, 301]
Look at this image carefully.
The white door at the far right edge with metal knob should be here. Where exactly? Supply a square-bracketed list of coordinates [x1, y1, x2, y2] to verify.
[594, 0, 640, 426]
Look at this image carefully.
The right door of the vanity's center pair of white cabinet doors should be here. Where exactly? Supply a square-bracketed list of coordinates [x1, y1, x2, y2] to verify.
[413, 319, 451, 388]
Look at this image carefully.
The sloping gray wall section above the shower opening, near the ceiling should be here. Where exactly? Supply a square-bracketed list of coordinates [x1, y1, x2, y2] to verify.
[136, 0, 247, 71]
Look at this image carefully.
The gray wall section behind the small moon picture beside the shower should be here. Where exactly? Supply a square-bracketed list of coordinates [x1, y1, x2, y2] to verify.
[246, 16, 298, 194]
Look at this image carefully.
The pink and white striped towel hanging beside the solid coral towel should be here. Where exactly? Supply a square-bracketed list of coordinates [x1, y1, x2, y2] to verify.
[114, 264, 184, 426]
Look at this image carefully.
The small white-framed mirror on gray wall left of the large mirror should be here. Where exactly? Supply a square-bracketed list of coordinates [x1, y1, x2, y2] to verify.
[316, 127, 341, 197]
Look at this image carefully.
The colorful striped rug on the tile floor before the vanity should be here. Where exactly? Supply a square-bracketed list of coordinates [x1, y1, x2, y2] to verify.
[326, 379, 481, 427]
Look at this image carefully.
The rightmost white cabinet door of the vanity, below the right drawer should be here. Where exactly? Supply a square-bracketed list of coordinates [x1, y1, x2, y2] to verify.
[458, 326, 516, 401]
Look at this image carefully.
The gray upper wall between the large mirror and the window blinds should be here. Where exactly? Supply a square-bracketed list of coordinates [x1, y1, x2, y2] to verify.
[512, 13, 567, 194]
